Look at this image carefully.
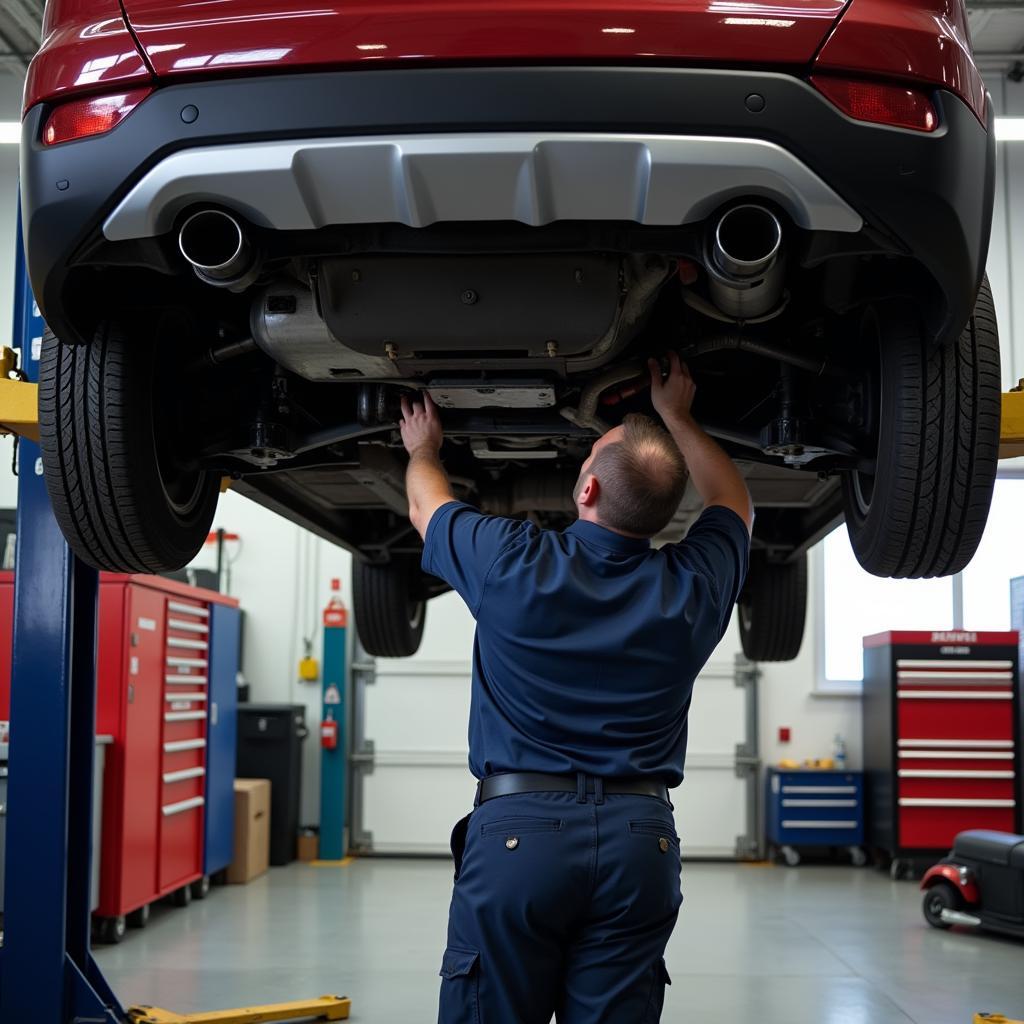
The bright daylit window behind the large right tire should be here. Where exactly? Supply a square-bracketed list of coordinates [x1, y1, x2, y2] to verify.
[815, 476, 1024, 692]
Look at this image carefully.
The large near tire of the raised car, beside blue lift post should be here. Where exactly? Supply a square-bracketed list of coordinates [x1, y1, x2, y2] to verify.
[39, 321, 219, 572]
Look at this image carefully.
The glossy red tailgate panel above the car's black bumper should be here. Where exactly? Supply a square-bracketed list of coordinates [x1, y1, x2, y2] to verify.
[114, 0, 846, 77]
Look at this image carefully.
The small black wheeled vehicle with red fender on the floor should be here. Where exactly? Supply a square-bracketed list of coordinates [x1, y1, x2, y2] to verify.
[921, 830, 1024, 938]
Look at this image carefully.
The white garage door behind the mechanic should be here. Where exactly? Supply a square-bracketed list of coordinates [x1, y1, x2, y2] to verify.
[352, 594, 758, 857]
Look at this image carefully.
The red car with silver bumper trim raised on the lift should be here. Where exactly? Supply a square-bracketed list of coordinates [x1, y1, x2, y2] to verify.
[22, 0, 1000, 659]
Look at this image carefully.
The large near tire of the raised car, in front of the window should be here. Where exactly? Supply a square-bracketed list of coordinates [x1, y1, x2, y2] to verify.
[843, 279, 1001, 579]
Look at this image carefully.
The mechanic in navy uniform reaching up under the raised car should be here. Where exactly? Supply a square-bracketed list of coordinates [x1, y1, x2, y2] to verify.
[401, 353, 754, 1024]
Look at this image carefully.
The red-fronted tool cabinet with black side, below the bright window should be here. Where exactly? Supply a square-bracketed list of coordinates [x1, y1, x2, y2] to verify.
[863, 632, 1024, 874]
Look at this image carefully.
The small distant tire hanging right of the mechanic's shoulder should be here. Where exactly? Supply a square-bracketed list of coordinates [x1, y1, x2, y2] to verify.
[736, 551, 807, 662]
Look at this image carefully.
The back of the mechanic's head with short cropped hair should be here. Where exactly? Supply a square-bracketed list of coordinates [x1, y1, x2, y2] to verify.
[572, 415, 686, 537]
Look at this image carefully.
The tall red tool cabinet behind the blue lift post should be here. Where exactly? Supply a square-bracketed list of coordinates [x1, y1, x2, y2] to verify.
[0, 572, 238, 919]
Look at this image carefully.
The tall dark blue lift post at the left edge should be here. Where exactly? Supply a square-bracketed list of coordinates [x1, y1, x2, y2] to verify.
[0, 234, 124, 1024]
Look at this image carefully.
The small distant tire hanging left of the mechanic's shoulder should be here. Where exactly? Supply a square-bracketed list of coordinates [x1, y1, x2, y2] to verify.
[352, 559, 427, 657]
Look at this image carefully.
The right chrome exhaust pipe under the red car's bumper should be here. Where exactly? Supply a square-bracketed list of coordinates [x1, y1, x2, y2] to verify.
[707, 203, 785, 319]
